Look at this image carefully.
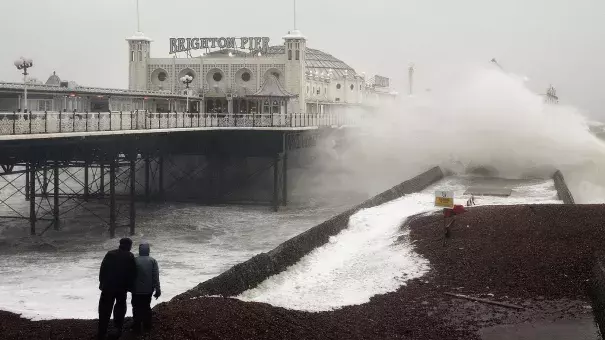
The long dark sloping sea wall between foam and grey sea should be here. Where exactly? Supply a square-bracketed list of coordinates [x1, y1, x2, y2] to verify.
[174, 167, 444, 300]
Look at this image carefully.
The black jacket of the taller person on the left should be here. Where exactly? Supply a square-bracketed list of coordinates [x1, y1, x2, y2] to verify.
[99, 244, 137, 292]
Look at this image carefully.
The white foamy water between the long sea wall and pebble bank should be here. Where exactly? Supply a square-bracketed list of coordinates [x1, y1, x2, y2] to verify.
[238, 177, 561, 311]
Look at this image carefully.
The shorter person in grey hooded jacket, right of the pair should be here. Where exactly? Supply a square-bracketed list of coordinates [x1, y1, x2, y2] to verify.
[132, 243, 162, 331]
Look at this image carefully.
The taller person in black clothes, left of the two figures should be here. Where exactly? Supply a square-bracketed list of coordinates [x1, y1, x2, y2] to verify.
[98, 238, 137, 339]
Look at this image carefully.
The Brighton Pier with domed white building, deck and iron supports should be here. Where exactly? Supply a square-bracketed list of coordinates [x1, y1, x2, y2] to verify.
[0, 31, 396, 237]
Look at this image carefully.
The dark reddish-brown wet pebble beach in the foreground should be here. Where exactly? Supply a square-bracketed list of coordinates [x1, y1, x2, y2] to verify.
[0, 205, 605, 340]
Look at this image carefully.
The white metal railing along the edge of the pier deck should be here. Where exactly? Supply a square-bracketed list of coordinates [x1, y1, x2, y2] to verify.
[0, 111, 359, 135]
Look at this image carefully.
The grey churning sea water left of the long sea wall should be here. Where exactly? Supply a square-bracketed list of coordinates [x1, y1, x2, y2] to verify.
[0, 204, 345, 320]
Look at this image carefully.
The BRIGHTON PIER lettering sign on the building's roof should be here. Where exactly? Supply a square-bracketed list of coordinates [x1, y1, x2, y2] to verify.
[170, 37, 269, 54]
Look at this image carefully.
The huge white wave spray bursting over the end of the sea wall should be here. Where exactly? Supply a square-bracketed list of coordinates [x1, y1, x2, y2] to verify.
[330, 67, 605, 203]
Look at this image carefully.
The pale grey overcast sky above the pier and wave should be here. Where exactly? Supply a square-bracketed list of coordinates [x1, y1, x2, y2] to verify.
[0, 0, 605, 119]
